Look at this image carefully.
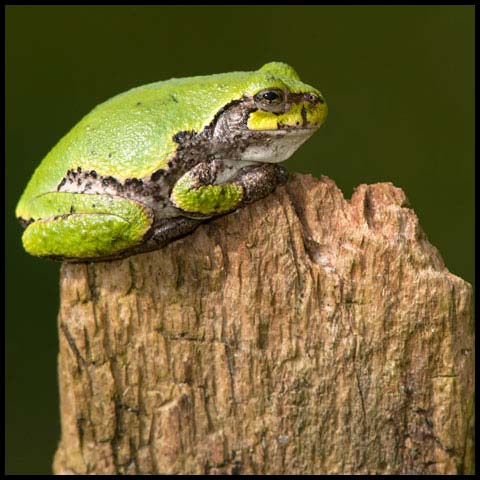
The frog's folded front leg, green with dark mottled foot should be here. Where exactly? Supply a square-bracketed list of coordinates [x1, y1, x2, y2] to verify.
[170, 161, 287, 218]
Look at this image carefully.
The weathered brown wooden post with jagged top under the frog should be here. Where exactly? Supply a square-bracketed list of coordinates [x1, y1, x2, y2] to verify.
[54, 175, 474, 474]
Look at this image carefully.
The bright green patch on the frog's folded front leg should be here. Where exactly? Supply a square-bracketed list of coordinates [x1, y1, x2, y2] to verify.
[170, 172, 243, 215]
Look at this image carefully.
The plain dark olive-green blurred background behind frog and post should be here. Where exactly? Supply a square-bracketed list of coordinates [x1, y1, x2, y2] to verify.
[6, 6, 474, 473]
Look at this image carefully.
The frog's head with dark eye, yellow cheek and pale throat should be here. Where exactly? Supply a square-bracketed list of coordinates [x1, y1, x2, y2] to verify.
[215, 62, 327, 162]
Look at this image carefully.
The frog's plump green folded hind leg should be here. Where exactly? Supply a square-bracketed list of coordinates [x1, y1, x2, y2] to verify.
[22, 193, 152, 259]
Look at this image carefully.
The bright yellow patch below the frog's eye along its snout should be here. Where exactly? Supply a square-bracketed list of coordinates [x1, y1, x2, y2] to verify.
[247, 102, 324, 130]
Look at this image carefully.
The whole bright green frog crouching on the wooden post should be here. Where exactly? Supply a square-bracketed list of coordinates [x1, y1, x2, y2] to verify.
[16, 62, 327, 261]
